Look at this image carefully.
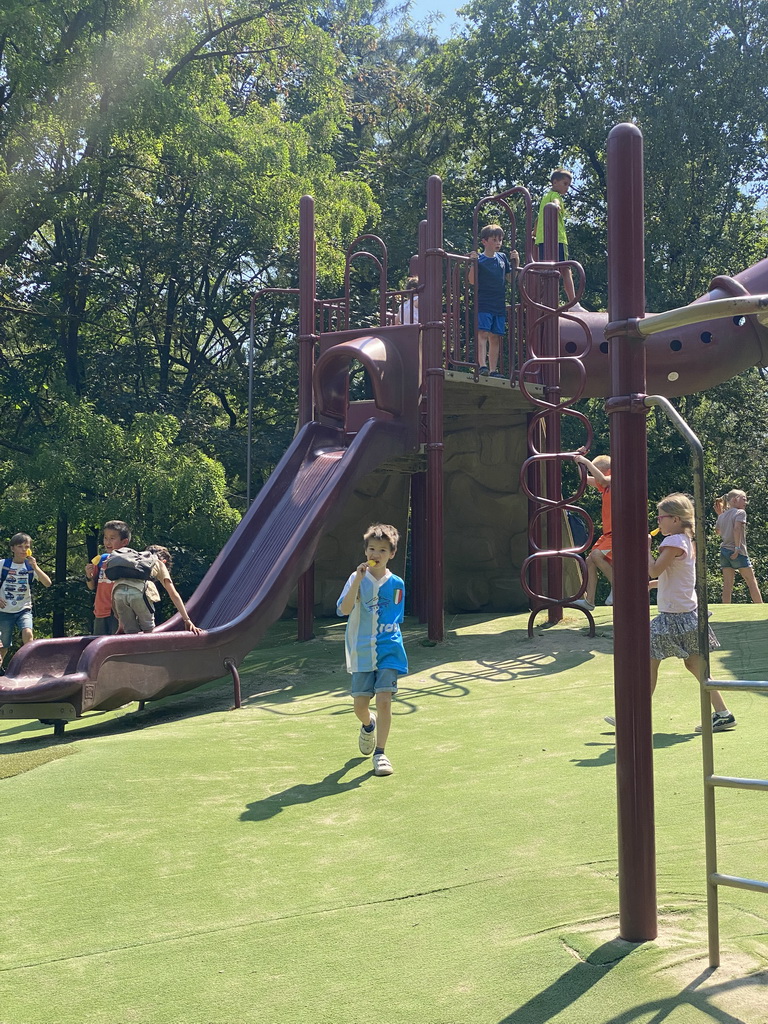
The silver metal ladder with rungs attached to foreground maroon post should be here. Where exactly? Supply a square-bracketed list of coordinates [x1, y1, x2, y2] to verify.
[644, 391, 768, 967]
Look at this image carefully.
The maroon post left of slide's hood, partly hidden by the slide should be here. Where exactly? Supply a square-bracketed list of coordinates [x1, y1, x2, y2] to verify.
[296, 196, 317, 640]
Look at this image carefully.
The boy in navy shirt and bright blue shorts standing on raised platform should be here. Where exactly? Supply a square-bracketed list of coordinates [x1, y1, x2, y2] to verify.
[469, 224, 519, 377]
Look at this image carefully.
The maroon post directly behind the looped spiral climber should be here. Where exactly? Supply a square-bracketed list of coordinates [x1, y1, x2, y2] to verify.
[540, 203, 563, 625]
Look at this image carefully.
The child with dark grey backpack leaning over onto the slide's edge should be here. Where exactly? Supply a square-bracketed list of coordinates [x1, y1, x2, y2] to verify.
[104, 544, 203, 633]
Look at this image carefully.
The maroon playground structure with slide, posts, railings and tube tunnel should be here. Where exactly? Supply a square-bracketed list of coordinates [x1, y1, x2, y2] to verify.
[0, 125, 768, 958]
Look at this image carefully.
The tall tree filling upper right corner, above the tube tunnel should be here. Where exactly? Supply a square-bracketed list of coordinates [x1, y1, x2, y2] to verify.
[421, 0, 768, 309]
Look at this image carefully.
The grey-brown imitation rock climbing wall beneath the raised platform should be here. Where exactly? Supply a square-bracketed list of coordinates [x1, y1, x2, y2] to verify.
[303, 371, 530, 615]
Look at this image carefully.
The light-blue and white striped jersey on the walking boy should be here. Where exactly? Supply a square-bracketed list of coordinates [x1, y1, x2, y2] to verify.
[336, 569, 408, 676]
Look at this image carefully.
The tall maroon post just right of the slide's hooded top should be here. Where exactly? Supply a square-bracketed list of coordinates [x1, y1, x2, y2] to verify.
[419, 174, 445, 641]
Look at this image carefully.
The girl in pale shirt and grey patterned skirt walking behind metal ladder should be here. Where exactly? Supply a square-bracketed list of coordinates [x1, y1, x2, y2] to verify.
[648, 494, 736, 732]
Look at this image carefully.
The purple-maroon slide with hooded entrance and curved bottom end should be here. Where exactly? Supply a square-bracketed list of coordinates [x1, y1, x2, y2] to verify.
[0, 328, 419, 731]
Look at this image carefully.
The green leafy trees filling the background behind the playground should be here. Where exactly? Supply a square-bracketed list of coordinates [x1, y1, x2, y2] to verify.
[0, 0, 768, 629]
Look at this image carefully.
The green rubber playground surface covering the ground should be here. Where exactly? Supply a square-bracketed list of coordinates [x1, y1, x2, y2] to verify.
[0, 605, 768, 1024]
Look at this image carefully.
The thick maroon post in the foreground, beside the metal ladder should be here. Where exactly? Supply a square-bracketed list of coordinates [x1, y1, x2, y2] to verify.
[606, 124, 657, 942]
